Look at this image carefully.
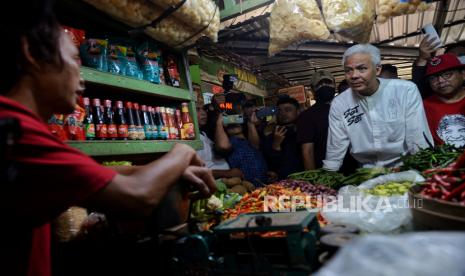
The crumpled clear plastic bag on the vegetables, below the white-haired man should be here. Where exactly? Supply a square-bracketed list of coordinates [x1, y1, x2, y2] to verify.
[321, 171, 425, 232]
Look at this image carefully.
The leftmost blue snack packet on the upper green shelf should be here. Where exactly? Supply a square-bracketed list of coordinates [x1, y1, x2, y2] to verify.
[81, 38, 108, 71]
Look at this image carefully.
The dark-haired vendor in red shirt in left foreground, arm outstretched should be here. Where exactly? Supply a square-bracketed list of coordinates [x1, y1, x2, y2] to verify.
[0, 0, 215, 276]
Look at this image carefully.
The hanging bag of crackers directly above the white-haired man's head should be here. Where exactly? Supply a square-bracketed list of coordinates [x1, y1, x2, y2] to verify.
[321, 0, 375, 43]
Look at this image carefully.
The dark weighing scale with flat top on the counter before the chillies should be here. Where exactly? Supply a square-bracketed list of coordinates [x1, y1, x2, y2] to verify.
[214, 210, 320, 275]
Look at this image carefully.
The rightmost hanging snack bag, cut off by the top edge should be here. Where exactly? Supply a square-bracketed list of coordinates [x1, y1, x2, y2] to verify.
[376, 0, 431, 24]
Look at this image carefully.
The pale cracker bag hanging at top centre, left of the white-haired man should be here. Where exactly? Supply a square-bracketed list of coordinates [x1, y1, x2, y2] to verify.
[268, 0, 329, 56]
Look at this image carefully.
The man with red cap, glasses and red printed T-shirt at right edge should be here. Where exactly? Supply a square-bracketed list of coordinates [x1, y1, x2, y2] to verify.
[423, 54, 465, 147]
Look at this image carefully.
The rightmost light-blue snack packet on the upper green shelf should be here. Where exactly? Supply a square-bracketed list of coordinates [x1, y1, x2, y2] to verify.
[137, 42, 161, 84]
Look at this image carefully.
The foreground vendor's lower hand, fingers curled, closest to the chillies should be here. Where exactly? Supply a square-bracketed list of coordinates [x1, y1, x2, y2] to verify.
[182, 166, 216, 197]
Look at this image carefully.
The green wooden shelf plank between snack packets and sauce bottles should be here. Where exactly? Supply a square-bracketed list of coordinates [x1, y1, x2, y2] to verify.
[81, 67, 191, 101]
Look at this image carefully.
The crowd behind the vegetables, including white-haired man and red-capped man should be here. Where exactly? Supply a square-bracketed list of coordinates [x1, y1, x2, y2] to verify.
[198, 36, 465, 186]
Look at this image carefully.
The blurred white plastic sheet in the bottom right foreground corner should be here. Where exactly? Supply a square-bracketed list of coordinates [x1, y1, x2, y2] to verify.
[315, 232, 465, 276]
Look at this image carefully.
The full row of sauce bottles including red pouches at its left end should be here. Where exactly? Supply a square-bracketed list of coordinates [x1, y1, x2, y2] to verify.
[49, 98, 195, 140]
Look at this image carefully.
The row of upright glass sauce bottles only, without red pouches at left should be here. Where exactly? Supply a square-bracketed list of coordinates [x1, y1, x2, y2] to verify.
[84, 98, 195, 140]
